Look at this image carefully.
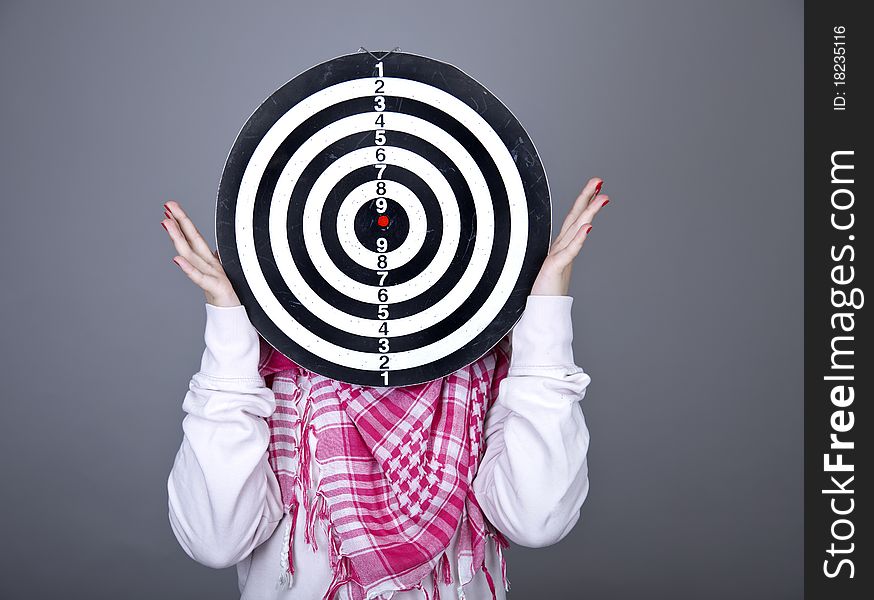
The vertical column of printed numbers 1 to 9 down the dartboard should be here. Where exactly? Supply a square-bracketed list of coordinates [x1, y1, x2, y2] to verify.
[373, 61, 391, 385]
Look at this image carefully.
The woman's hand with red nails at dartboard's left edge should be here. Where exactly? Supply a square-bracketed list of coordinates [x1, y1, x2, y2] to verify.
[161, 200, 242, 306]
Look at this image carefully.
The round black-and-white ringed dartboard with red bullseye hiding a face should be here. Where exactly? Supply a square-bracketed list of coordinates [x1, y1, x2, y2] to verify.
[216, 51, 552, 387]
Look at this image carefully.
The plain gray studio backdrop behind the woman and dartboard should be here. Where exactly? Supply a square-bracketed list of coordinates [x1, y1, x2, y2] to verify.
[0, 0, 803, 600]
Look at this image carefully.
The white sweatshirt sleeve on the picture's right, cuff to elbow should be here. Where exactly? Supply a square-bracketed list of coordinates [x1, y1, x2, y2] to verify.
[473, 295, 591, 548]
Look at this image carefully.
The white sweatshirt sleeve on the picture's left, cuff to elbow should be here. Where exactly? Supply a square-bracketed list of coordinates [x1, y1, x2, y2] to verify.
[167, 303, 283, 568]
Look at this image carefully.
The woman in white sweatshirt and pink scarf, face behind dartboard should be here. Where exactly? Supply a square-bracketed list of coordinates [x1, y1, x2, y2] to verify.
[161, 178, 608, 600]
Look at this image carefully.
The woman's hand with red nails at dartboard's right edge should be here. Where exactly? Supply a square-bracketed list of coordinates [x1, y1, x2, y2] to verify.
[531, 177, 609, 296]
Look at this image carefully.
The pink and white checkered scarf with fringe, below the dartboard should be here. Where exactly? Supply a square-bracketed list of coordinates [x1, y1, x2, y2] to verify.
[259, 335, 510, 600]
